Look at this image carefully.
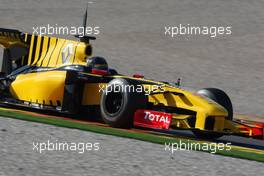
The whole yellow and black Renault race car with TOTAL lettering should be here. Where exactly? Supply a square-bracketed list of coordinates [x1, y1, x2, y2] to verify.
[0, 23, 263, 138]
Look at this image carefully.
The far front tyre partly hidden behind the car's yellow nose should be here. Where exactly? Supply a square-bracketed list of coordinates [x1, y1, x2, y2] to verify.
[193, 88, 233, 139]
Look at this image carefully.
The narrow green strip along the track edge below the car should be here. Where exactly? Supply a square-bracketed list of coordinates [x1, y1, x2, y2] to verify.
[0, 110, 264, 162]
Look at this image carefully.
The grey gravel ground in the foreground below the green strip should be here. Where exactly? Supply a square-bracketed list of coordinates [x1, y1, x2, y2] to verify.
[0, 118, 263, 176]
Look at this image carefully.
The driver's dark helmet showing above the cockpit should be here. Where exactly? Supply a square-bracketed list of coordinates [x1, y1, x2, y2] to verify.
[87, 56, 108, 71]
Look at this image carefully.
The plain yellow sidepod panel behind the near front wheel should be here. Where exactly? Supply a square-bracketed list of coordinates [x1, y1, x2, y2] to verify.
[10, 71, 66, 106]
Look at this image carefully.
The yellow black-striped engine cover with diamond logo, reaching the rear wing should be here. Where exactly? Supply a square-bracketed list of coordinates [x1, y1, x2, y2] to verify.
[0, 28, 92, 74]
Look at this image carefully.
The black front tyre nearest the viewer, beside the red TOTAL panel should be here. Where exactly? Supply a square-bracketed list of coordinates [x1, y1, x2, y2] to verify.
[100, 78, 147, 128]
